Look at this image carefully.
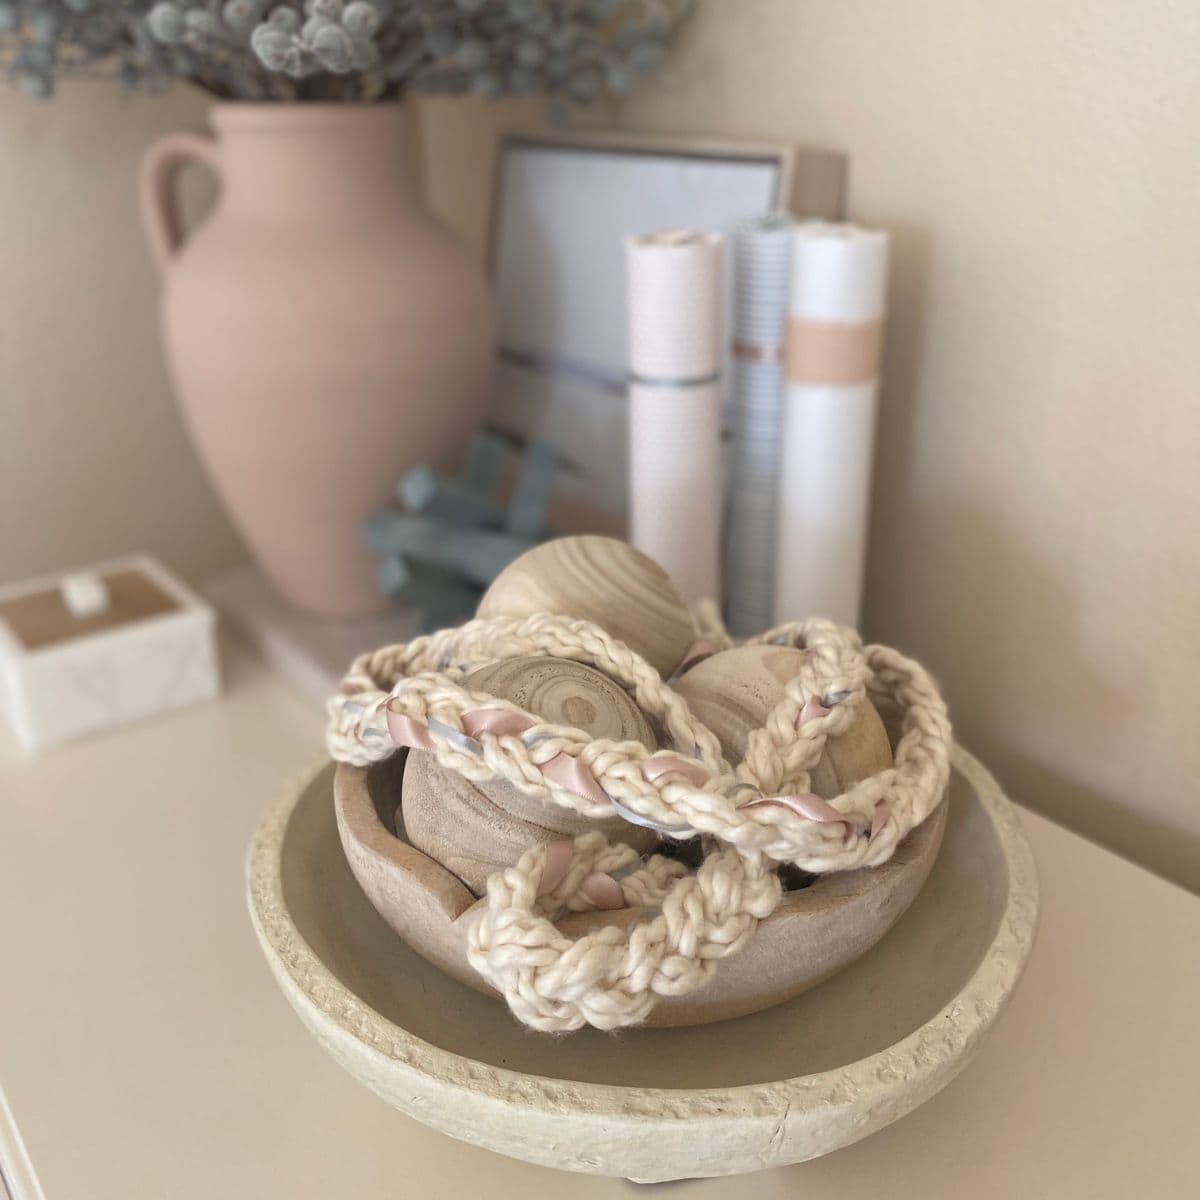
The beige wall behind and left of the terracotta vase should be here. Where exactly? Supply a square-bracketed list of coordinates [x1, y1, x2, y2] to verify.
[0, 83, 542, 582]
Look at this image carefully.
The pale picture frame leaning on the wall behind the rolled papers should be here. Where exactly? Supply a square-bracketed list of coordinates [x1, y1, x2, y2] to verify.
[488, 133, 845, 518]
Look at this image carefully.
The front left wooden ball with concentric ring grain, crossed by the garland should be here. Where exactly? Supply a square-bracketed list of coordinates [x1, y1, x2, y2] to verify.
[401, 658, 658, 895]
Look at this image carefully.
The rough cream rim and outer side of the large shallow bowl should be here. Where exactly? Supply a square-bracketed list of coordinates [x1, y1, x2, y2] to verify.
[247, 748, 1039, 1182]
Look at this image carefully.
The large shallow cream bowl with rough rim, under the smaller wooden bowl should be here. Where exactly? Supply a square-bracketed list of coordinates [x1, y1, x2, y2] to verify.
[247, 750, 1038, 1182]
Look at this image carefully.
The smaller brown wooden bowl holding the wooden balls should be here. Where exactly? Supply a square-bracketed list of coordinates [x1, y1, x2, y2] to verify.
[334, 755, 946, 1027]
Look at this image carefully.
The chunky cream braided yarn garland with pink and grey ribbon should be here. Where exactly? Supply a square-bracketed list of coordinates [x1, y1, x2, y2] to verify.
[328, 613, 950, 1032]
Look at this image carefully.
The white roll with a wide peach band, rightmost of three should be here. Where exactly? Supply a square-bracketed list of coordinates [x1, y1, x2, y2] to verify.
[774, 222, 888, 626]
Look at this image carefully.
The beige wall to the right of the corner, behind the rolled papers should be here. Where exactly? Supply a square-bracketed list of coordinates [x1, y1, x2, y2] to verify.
[624, 0, 1200, 892]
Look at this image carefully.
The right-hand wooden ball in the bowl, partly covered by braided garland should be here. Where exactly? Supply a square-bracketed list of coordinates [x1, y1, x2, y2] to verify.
[674, 644, 892, 799]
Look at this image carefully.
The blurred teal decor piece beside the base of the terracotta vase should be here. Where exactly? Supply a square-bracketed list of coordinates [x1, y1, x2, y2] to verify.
[362, 430, 562, 631]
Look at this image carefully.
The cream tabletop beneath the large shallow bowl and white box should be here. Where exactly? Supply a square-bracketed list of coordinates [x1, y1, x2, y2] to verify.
[0, 646, 1200, 1200]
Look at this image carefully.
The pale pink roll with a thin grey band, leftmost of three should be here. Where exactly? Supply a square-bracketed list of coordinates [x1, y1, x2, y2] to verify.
[626, 233, 722, 600]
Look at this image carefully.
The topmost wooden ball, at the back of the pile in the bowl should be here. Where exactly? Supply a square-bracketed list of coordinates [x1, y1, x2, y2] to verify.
[479, 536, 695, 677]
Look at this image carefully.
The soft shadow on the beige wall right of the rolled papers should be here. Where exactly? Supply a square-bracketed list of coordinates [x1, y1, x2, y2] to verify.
[864, 216, 1200, 890]
